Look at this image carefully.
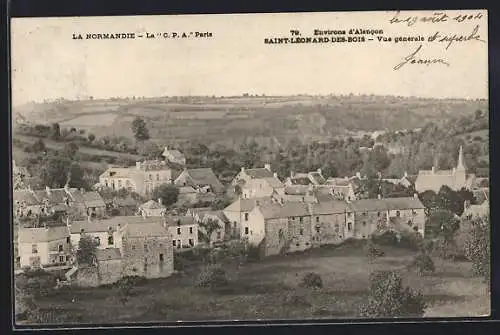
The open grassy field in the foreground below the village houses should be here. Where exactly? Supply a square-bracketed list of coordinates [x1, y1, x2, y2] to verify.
[22, 245, 490, 324]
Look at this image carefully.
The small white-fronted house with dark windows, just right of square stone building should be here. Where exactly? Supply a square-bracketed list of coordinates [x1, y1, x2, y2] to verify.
[166, 215, 199, 251]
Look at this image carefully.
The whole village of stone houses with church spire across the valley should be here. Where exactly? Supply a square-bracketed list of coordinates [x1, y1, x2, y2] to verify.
[13, 147, 489, 287]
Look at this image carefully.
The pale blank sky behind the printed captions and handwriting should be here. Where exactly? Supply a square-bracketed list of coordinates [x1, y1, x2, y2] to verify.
[11, 10, 488, 106]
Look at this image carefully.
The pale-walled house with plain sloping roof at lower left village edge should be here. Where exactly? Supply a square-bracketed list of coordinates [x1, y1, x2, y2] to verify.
[17, 224, 73, 269]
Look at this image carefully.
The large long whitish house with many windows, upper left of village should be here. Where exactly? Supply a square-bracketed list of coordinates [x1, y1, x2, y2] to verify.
[96, 160, 173, 195]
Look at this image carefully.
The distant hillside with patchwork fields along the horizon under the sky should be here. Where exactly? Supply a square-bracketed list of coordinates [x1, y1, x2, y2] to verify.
[13, 96, 488, 143]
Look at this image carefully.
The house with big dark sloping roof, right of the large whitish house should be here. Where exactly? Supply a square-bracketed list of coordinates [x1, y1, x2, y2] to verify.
[174, 168, 224, 194]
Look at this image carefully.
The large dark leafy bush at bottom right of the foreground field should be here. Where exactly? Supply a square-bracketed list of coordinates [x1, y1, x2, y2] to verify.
[359, 271, 426, 318]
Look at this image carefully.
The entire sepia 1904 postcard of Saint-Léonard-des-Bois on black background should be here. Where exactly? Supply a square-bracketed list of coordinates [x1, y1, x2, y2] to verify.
[11, 9, 490, 327]
